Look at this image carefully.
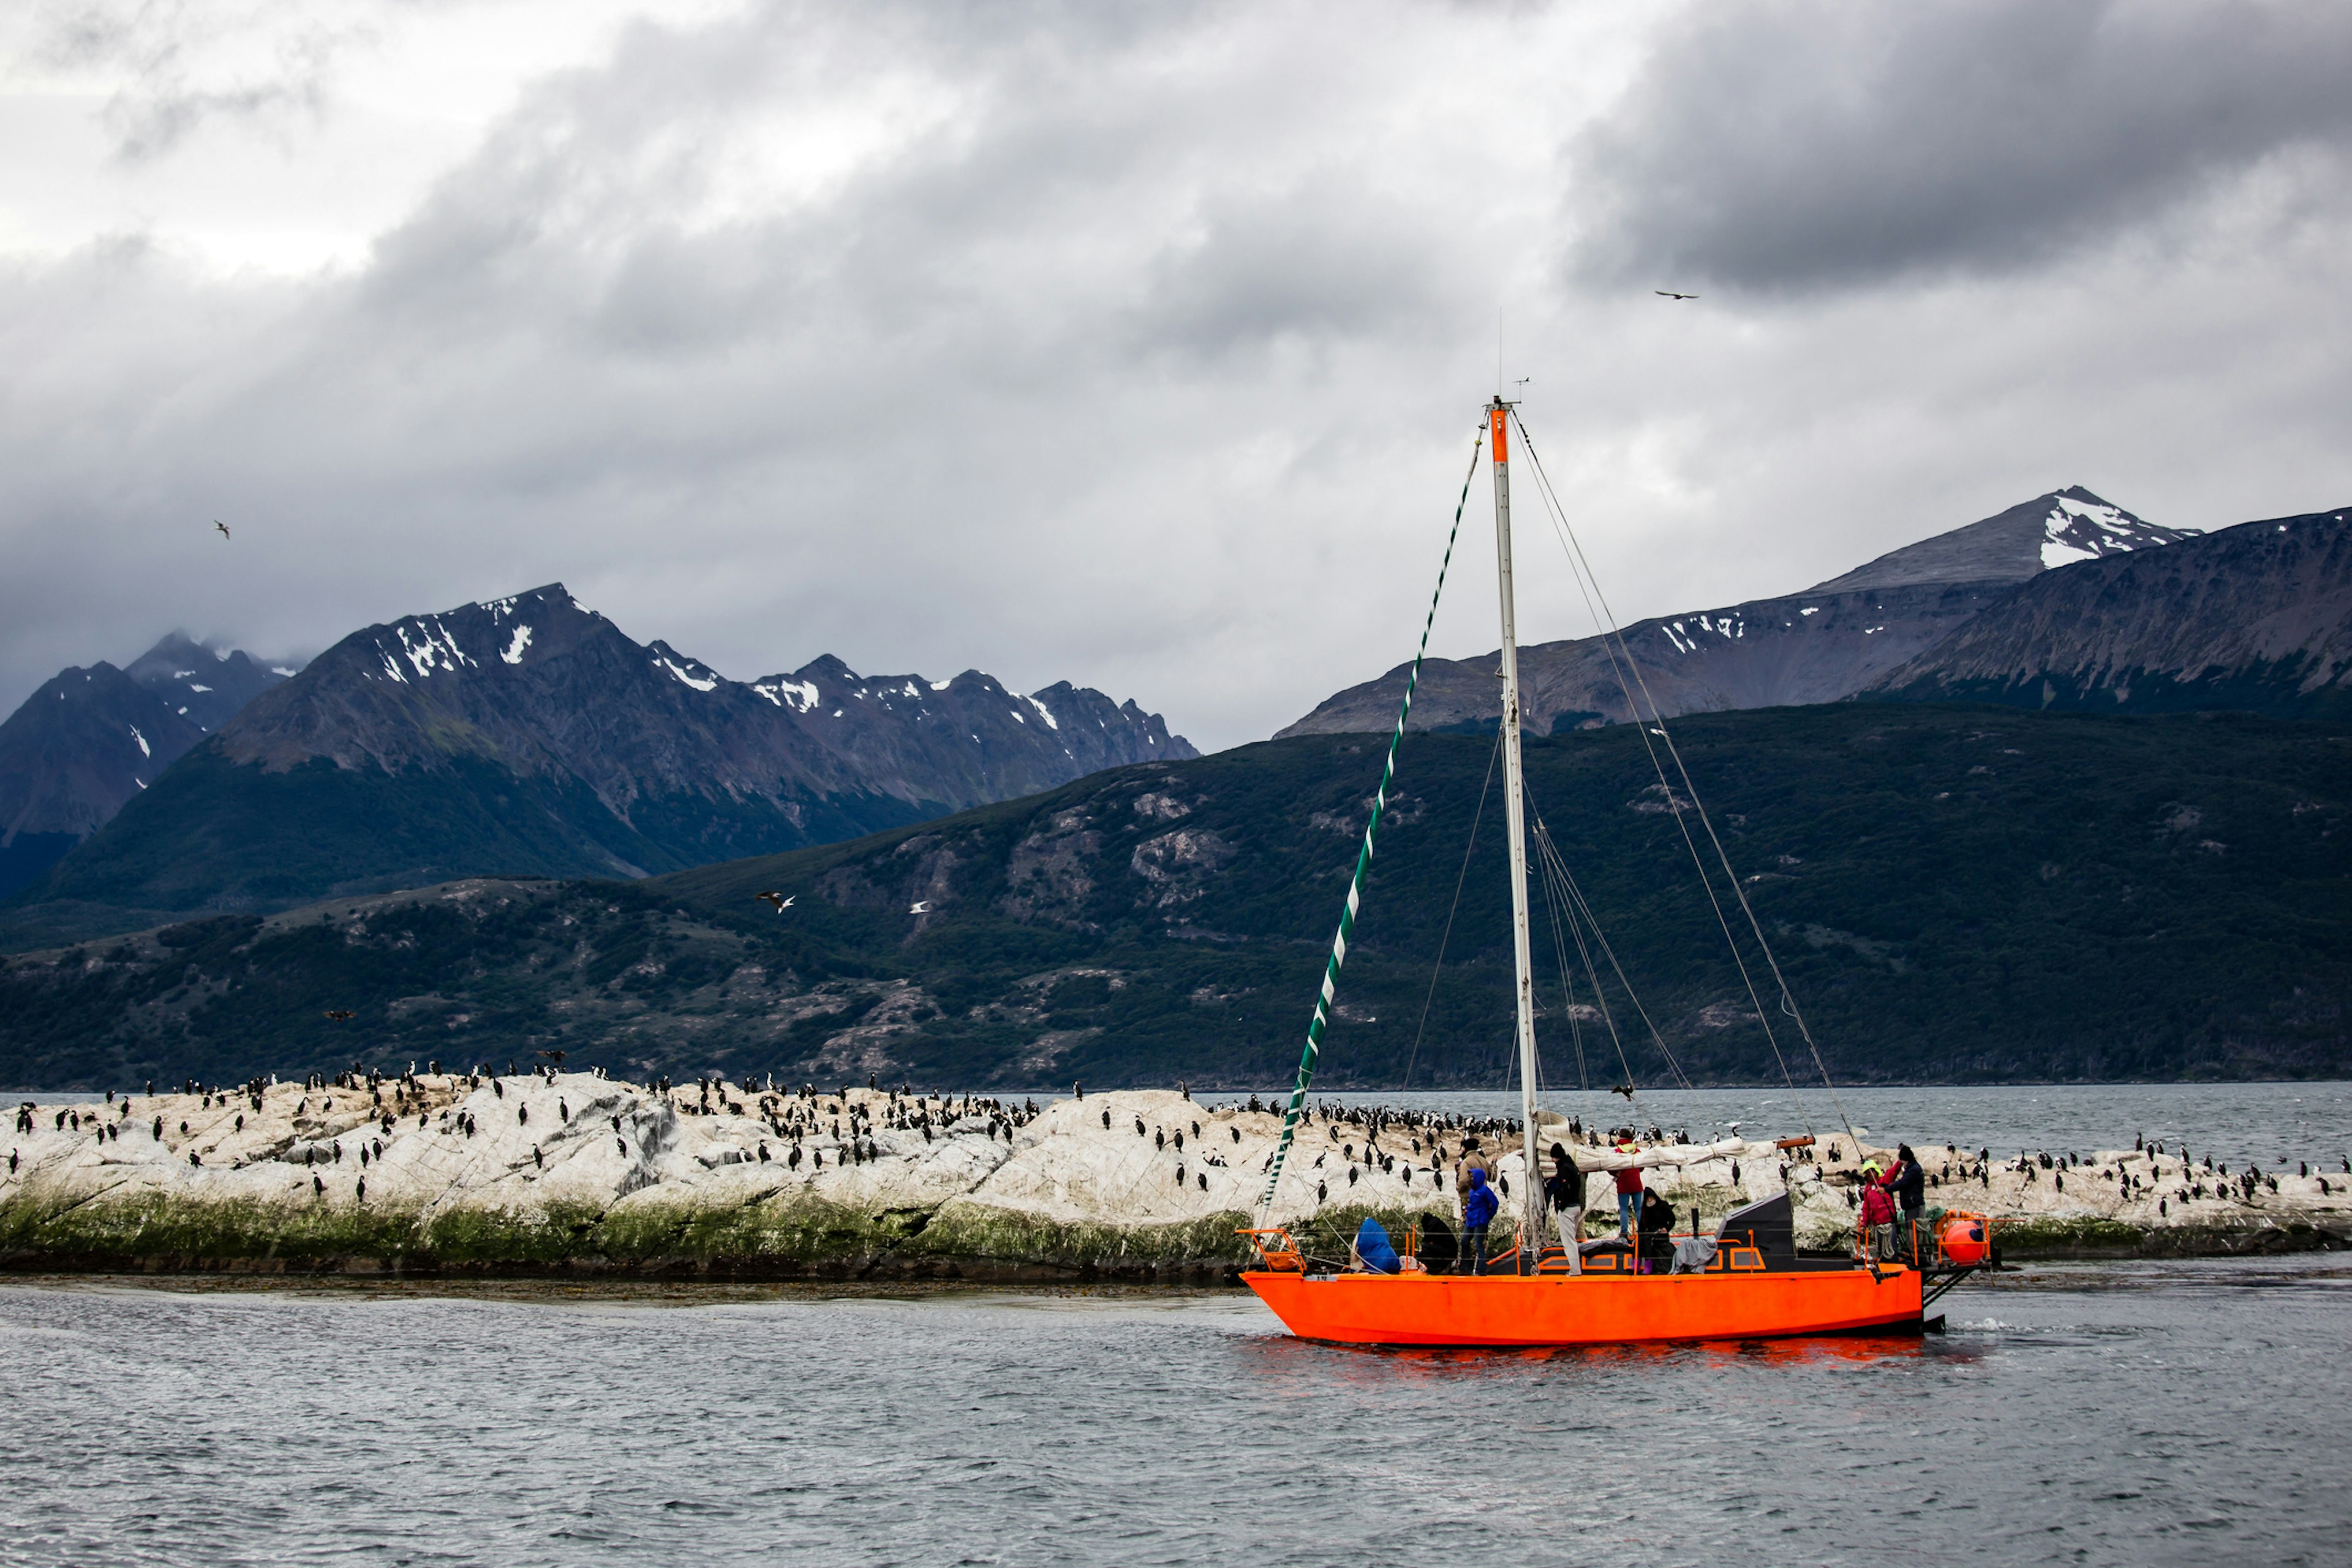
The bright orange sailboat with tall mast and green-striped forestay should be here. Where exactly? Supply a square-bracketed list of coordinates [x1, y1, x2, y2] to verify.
[1242, 395, 1985, 1344]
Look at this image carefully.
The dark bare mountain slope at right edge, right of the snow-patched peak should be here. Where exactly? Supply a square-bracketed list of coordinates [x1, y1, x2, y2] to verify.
[1872, 513, 2352, 717]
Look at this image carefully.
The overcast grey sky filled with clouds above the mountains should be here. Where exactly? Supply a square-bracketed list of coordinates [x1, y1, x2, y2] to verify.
[0, 0, 2352, 748]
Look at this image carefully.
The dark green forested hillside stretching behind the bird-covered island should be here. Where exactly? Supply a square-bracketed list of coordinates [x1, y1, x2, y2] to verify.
[0, 703, 2352, 1088]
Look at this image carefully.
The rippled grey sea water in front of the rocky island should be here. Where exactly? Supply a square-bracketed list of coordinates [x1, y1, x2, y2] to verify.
[0, 1257, 2352, 1568]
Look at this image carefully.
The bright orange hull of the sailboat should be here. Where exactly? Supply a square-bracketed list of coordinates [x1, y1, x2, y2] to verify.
[1242, 1267, 1921, 1344]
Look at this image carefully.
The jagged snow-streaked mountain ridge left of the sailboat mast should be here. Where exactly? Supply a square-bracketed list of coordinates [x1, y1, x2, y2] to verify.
[28, 583, 1195, 910]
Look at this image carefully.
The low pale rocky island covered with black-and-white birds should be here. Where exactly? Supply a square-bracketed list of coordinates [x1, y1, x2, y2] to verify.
[0, 1067, 2352, 1284]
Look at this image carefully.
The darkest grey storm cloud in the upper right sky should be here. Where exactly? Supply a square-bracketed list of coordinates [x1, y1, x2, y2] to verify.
[1576, 0, 2352, 289]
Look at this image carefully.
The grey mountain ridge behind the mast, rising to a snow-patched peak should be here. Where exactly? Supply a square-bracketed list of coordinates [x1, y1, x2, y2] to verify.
[1277, 486, 2190, 738]
